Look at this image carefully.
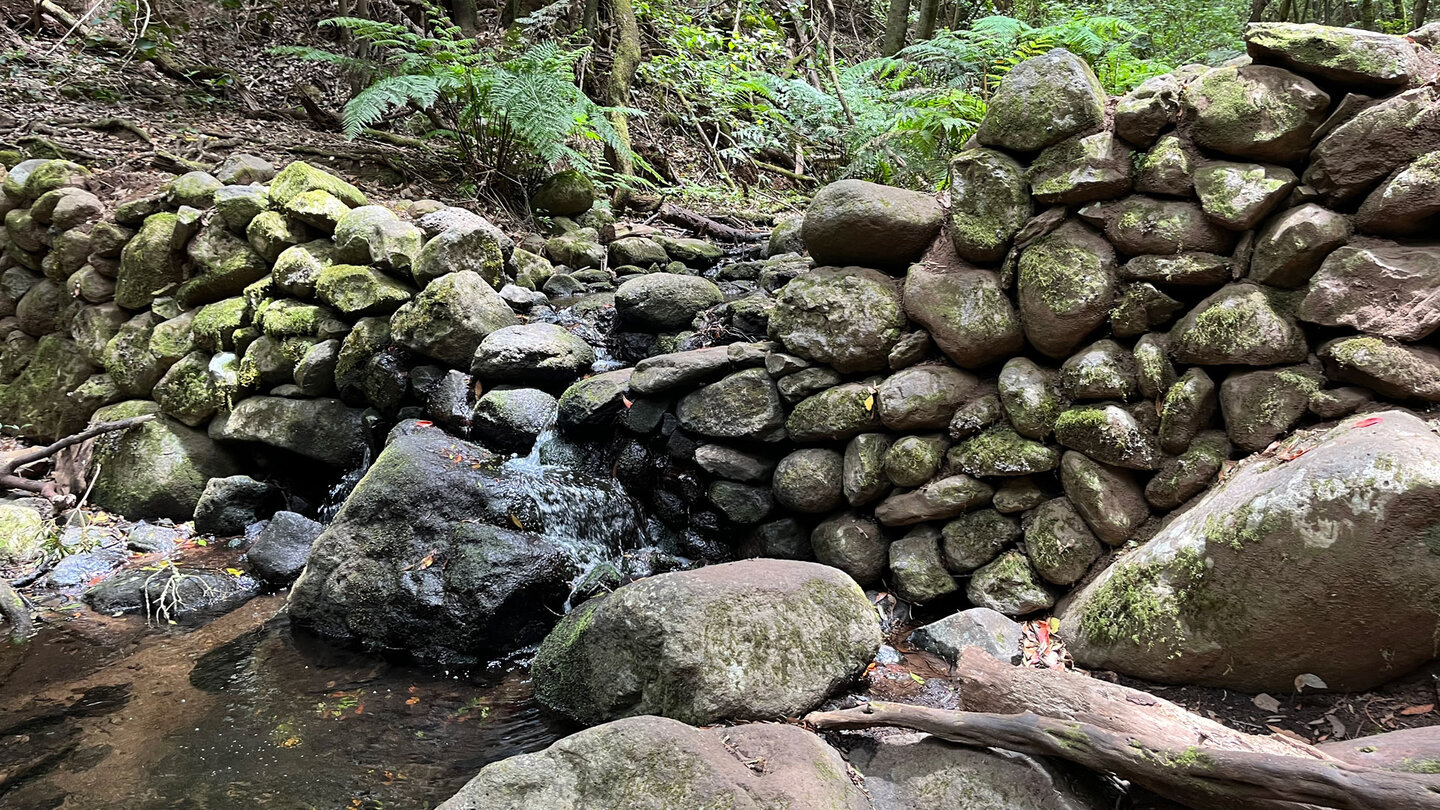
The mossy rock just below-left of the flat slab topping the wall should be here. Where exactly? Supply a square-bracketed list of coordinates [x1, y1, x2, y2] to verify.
[1181, 65, 1331, 163]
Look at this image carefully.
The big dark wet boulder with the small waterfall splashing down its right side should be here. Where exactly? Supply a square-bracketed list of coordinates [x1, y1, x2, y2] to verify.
[289, 422, 601, 663]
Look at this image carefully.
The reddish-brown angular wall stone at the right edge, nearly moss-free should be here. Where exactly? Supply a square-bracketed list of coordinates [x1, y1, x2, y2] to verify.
[1297, 241, 1440, 340]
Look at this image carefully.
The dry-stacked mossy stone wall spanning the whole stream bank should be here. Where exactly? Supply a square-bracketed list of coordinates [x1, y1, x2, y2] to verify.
[0, 25, 1440, 648]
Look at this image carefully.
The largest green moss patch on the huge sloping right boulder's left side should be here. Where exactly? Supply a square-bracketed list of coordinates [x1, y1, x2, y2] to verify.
[1080, 549, 1208, 650]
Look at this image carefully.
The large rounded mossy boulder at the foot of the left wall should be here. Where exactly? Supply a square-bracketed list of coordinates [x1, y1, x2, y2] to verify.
[91, 399, 239, 520]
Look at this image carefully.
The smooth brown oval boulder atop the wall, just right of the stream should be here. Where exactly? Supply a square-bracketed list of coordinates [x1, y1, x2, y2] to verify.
[801, 180, 945, 271]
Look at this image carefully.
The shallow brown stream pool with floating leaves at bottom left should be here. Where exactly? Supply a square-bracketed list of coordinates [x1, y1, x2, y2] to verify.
[0, 597, 570, 810]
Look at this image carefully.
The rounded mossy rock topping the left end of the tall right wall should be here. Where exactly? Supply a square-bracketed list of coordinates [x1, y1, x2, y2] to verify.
[975, 48, 1106, 151]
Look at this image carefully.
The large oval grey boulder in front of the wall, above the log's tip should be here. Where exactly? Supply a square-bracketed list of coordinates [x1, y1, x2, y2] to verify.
[531, 559, 880, 725]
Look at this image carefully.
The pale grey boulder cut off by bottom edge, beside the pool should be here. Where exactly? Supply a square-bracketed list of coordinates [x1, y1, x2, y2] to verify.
[439, 716, 864, 810]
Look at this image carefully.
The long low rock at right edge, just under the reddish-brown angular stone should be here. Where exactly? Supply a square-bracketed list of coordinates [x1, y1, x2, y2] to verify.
[1318, 337, 1440, 402]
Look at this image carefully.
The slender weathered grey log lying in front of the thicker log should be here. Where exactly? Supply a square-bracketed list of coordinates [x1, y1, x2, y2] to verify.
[805, 703, 1440, 810]
